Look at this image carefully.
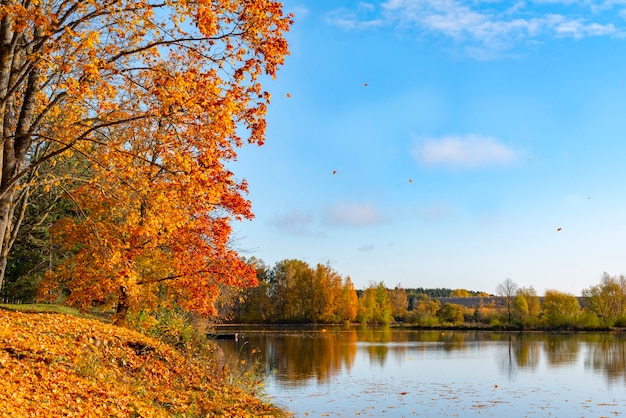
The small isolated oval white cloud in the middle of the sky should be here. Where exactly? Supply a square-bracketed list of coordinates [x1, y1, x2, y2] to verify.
[412, 135, 518, 168]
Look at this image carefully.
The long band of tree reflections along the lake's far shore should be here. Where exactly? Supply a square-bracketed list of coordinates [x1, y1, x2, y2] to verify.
[213, 327, 626, 386]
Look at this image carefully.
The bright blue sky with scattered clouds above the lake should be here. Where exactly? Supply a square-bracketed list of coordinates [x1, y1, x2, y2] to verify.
[233, 0, 626, 295]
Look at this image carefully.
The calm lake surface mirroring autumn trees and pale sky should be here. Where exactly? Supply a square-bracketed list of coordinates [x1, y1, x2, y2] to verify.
[214, 328, 626, 417]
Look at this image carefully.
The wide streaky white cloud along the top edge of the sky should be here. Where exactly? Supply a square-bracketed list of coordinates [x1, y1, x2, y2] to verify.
[327, 0, 626, 56]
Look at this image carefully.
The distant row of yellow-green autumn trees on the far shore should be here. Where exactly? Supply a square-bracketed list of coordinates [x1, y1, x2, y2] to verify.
[221, 260, 626, 329]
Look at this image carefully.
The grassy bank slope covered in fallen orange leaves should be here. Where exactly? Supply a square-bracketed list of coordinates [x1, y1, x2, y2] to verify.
[0, 310, 281, 417]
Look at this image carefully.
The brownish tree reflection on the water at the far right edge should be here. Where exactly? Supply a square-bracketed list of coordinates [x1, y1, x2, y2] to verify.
[585, 335, 626, 382]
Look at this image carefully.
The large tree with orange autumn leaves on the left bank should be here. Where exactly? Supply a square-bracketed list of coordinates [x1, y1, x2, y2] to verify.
[5, 0, 291, 322]
